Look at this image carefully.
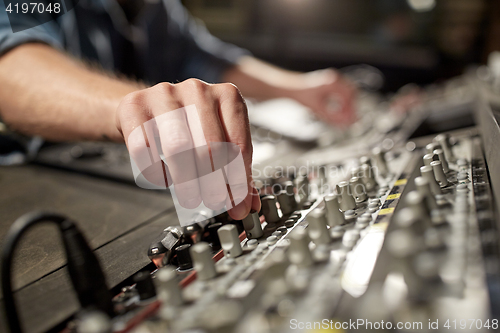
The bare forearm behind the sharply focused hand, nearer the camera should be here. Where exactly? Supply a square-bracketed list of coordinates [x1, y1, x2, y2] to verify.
[0, 44, 142, 141]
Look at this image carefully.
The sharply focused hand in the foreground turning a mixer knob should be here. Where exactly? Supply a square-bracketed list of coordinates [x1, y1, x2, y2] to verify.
[116, 79, 260, 220]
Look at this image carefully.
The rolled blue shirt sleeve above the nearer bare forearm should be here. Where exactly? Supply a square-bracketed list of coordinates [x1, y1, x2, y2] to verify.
[0, 1, 63, 56]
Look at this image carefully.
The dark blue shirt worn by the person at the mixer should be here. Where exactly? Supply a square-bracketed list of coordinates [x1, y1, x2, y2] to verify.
[0, 0, 249, 84]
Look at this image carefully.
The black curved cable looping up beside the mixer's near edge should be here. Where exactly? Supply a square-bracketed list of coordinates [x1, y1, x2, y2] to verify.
[1, 212, 114, 333]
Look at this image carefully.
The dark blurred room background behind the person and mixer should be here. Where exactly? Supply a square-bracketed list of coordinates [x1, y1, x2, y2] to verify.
[183, 0, 500, 92]
